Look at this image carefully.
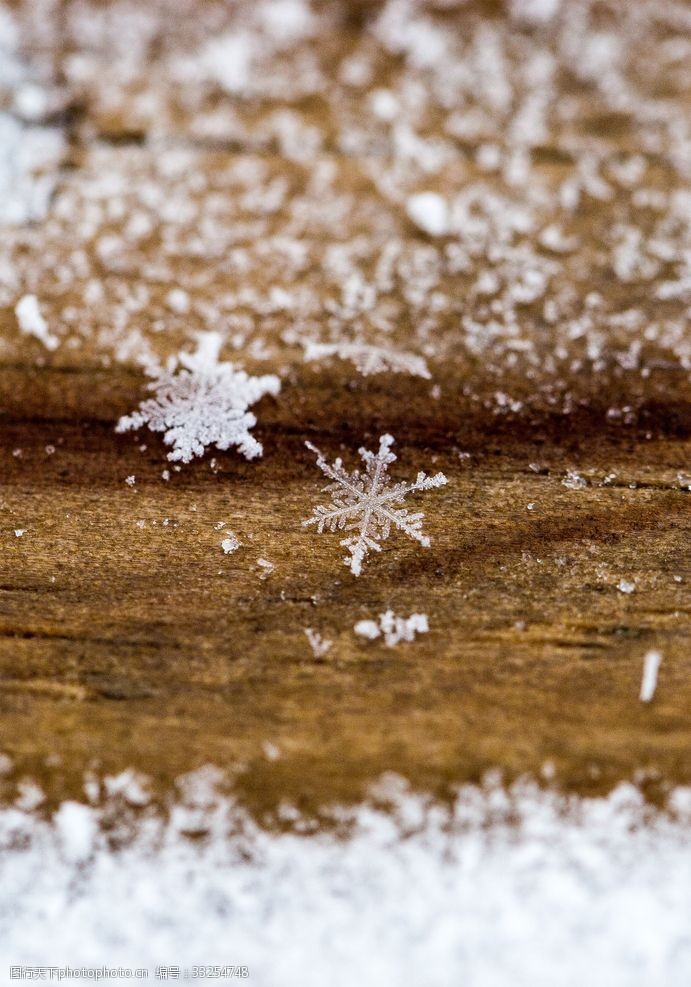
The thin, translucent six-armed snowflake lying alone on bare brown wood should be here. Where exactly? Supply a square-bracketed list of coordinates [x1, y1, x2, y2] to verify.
[303, 435, 447, 576]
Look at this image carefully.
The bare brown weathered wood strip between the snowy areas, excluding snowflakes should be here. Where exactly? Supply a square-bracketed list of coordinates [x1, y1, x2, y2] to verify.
[0, 0, 691, 814]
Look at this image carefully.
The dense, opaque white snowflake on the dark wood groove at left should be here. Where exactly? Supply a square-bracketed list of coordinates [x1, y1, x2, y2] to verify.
[117, 332, 281, 463]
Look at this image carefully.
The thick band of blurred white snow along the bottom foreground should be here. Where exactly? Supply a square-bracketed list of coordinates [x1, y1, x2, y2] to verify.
[0, 772, 691, 987]
